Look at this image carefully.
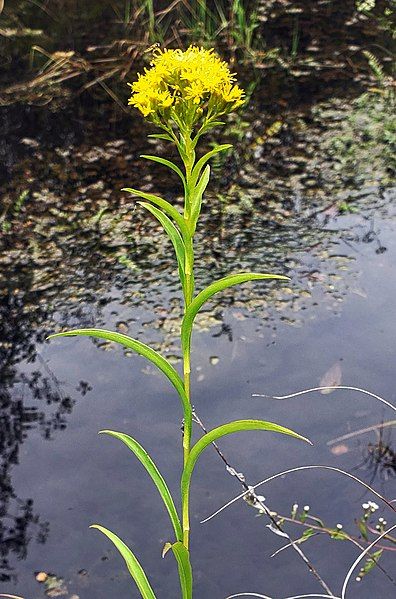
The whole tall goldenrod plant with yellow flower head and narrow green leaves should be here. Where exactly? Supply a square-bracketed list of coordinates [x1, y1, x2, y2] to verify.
[48, 46, 307, 599]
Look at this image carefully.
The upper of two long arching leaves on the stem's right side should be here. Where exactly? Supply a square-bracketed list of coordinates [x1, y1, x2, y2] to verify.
[181, 272, 289, 350]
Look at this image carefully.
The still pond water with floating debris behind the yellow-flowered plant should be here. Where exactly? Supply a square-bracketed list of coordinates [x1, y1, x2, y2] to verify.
[0, 86, 396, 599]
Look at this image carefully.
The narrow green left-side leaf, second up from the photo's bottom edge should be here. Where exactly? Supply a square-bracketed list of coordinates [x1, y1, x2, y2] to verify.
[99, 430, 183, 541]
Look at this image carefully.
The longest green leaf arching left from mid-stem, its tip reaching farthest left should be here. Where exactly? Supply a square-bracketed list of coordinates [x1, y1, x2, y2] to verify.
[48, 329, 191, 413]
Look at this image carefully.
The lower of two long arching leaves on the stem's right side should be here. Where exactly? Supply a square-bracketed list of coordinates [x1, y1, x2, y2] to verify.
[181, 420, 312, 496]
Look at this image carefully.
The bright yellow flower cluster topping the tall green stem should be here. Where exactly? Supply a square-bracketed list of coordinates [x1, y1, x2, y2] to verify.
[128, 46, 244, 124]
